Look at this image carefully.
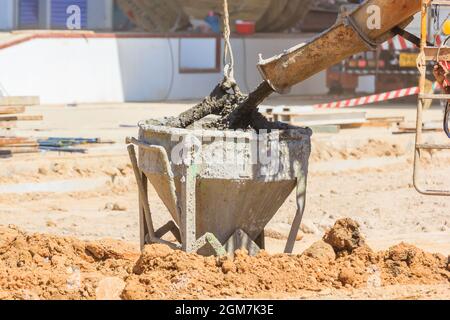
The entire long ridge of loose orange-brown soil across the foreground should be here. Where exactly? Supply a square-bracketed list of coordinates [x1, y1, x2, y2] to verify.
[0, 219, 450, 299]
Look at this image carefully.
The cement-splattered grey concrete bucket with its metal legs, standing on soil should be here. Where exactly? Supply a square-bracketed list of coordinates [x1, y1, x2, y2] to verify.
[127, 122, 311, 255]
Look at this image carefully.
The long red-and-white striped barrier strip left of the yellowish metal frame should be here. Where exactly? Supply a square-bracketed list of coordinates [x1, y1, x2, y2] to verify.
[313, 87, 419, 109]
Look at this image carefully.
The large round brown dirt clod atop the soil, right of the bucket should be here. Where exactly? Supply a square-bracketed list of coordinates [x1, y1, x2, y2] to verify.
[323, 218, 365, 254]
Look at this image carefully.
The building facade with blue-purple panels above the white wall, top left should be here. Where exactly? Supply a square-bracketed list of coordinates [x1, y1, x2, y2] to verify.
[0, 0, 117, 31]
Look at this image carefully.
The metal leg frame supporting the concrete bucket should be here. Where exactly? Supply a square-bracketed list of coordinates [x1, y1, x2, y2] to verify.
[126, 138, 307, 256]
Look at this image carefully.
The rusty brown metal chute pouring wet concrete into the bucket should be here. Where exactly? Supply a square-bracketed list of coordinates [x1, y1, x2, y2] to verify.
[258, 0, 422, 92]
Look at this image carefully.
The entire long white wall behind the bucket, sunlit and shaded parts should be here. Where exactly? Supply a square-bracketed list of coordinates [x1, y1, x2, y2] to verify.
[0, 38, 327, 103]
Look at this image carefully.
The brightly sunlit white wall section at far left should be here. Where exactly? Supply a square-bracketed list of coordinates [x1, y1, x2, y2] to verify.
[0, 39, 123, 103]
